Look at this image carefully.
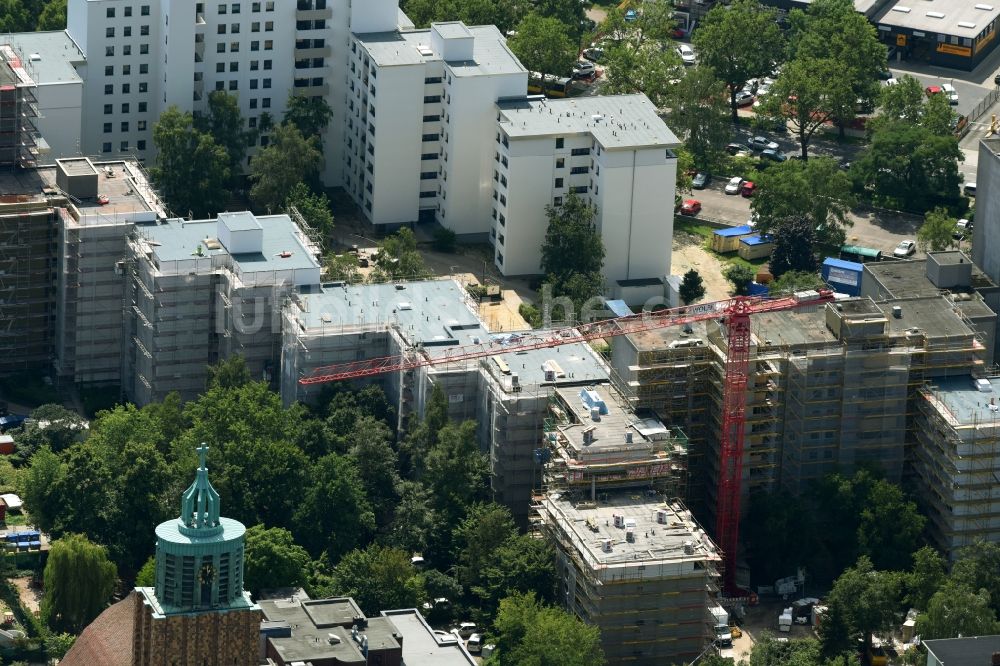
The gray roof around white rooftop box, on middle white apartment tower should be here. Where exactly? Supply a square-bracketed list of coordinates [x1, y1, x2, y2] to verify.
[357, 24, 528, 80]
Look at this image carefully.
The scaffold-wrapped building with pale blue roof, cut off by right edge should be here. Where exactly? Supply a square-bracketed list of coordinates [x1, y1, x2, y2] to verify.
[913, 376, 1000, 560]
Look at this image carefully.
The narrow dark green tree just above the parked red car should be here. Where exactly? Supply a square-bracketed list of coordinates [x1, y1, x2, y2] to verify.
[670, 65, 731, 171]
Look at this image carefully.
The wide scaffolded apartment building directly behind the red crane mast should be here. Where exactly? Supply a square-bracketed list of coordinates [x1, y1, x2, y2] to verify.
[611, 295, 985, 515]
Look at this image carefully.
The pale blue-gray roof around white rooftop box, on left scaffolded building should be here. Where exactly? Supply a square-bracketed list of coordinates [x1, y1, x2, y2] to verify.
[139, 215, 318, 273]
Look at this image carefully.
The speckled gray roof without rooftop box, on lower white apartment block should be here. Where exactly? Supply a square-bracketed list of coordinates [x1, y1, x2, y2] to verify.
[497, 94, 681, 150]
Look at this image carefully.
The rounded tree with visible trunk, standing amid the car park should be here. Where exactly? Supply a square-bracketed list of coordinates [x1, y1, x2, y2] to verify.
[760, 58, 857, 160]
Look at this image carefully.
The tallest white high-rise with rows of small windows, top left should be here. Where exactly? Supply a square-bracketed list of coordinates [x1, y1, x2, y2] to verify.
[67, 0, 407, 185]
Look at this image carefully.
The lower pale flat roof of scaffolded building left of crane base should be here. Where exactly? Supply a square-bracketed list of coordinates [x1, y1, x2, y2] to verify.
[544, 491, 720, 576]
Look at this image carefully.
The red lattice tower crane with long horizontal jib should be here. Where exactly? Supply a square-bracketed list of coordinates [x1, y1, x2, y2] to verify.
[299, 289, 833, 596]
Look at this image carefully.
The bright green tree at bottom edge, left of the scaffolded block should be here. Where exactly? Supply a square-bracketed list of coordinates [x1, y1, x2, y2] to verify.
[487, 592, 607, 666]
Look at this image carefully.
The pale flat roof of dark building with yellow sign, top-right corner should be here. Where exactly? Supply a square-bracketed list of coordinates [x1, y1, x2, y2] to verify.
[872, 0, 1000, 39]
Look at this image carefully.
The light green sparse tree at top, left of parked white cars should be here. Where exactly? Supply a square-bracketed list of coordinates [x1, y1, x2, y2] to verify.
[600, 3, 683, 108]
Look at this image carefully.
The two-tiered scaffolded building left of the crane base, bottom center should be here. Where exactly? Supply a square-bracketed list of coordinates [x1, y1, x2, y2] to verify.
[534, 384, 721, 664]
